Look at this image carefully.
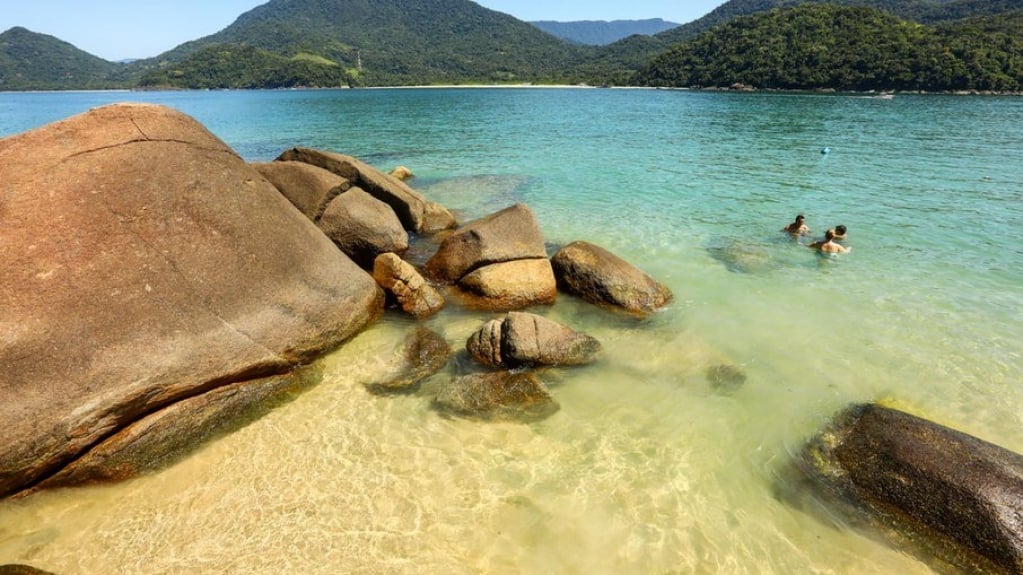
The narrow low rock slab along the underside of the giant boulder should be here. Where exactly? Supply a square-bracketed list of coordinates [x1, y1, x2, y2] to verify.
[26, 365, 322, 490]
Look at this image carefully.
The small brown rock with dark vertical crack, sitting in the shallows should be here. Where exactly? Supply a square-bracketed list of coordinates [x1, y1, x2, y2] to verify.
[465, 312, 601, 368]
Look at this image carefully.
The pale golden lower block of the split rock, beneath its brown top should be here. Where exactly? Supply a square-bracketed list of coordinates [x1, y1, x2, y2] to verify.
[458, 260, 558, 311]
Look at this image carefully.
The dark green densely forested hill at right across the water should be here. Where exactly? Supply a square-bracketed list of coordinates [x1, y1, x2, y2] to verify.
[633, 3, 1023, 91]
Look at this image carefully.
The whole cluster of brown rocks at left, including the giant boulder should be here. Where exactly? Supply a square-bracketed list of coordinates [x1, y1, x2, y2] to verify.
[0, 104, 670, 496]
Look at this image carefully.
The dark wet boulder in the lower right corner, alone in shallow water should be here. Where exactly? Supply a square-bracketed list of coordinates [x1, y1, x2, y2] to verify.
[800, 404, 1023, 573]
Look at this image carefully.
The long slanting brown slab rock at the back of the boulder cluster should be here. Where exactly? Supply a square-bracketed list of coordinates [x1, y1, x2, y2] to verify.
[277, 147, 427, 232]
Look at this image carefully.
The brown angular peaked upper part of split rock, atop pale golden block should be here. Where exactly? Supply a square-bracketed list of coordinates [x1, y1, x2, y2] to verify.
[426, 204, 547, 283]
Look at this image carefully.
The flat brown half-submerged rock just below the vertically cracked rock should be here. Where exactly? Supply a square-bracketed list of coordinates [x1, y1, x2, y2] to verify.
[434, 371, 559, 422]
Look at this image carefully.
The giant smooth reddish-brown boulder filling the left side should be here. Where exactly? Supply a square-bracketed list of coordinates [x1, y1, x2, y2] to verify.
[0, 104, 383, 496]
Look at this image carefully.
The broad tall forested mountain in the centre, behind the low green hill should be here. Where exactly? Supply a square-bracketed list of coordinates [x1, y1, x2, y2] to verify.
[138, 0, 581, 86]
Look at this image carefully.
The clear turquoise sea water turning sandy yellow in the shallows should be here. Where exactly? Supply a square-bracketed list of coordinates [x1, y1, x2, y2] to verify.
[0, 89, 1023, 574]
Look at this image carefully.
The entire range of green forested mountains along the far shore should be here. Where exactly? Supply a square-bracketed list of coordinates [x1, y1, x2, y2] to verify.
[0, 0, 1023, 91]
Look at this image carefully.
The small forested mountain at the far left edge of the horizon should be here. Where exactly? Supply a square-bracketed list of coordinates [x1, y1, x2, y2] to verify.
[0, 27, 121, 90]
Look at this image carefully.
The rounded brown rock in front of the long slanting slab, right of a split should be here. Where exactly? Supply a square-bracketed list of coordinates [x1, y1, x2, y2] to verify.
[318, 187, 408, 269]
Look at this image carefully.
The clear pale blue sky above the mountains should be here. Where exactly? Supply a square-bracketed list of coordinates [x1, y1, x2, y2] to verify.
[0, 0, 725, 60]
